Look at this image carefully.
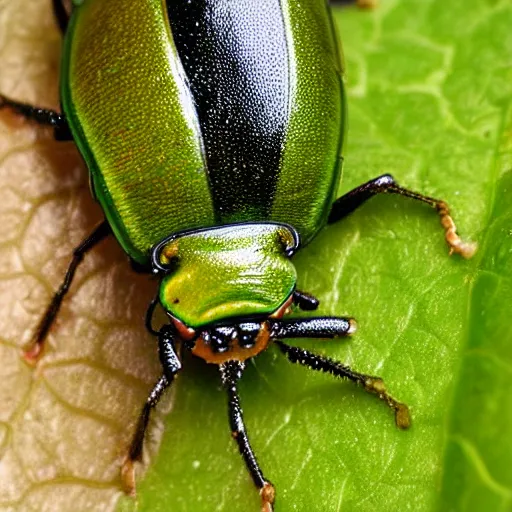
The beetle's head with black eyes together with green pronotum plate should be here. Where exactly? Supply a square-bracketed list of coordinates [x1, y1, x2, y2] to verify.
[152, 223, 299, 363]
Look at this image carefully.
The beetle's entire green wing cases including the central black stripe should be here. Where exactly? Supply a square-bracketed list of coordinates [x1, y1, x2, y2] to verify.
[61, 0, 345, 264]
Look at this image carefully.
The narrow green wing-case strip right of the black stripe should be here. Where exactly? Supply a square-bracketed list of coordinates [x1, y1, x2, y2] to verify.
[271, 0, 346, 238]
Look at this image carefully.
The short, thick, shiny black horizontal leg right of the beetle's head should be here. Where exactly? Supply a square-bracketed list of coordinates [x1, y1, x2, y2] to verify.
[269, 317, 357, 340]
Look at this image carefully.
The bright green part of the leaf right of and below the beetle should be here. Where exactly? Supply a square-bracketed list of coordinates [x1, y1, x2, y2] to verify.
[121, 0, 512, 512]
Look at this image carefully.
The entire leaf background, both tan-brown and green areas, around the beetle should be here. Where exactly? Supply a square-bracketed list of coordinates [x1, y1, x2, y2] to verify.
[0, 0, 512, 512]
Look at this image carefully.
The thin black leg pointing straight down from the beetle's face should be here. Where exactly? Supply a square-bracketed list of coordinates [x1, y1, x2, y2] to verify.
[220, 361, 275, 512]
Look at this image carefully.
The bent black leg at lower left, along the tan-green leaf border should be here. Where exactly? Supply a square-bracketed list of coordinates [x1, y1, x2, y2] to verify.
[121, 327, 181, 496]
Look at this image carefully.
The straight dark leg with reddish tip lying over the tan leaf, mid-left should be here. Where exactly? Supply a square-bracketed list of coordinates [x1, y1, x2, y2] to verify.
[24, 221, 112, 363]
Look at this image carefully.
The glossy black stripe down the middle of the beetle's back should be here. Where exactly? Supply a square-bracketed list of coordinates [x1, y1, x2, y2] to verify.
[166, 0, 289, 222]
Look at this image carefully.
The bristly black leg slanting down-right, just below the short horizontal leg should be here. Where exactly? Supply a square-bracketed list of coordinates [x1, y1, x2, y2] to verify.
[276, 342, 411, 429]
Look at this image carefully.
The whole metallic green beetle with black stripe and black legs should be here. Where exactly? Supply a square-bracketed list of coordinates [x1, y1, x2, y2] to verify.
[0, 0, 474, 511]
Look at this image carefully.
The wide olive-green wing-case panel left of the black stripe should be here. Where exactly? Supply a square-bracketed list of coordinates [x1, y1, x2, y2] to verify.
[61, 0, 215, 263]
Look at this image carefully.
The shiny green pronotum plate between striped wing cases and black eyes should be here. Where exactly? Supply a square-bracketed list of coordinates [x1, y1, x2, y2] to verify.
[159, 224, 297, 329]
